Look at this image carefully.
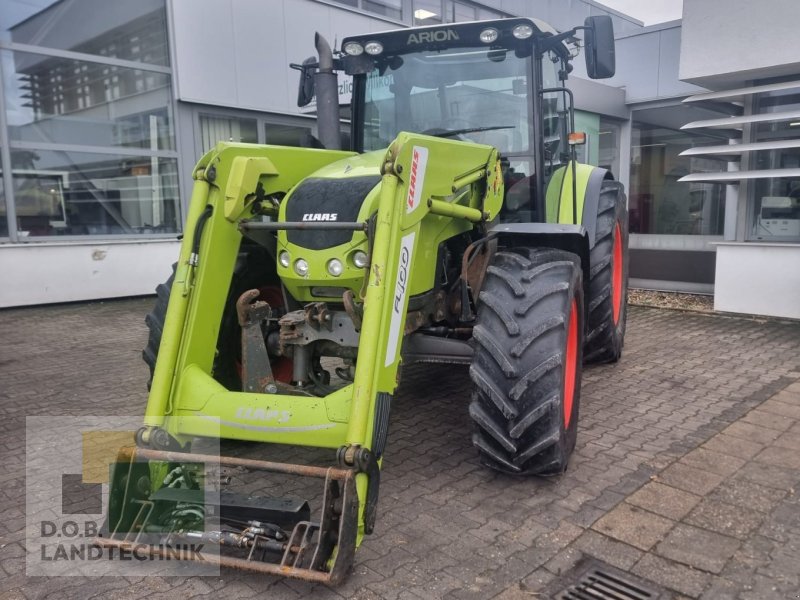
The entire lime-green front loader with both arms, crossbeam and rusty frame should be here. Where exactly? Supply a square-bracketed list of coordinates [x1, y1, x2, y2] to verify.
[104, 133, 503, 583]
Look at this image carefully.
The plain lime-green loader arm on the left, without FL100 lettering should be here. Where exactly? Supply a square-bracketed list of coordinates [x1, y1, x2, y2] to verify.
[143, 142, 353, 432]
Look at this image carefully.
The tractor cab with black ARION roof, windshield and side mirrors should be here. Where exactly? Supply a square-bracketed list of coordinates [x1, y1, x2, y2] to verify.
[301, 17, 614, 222]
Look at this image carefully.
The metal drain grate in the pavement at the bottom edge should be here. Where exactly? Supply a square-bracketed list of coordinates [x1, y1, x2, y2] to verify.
[552, 558, 664, 600]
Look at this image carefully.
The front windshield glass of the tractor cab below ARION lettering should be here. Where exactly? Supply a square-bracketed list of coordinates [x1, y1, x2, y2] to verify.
[364, 48, 530, 154]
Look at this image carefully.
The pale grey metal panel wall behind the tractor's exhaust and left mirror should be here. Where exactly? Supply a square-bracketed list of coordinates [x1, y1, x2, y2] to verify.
[172, 0, 390, 114]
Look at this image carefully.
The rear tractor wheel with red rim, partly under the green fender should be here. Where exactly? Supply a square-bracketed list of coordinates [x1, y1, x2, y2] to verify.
[583, 181, 628, 363]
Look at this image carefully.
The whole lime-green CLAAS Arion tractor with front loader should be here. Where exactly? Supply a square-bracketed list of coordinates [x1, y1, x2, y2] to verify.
[97, 17, 628, 584]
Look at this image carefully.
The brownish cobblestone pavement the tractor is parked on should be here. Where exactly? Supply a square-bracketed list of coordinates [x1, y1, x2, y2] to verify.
[0, 299, 800, 600]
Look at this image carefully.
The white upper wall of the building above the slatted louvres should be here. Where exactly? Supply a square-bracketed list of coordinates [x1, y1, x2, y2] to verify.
[680, 0, 800, 88]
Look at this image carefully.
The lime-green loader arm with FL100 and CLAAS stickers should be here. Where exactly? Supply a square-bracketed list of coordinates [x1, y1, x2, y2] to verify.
[340, 133, 503, 540]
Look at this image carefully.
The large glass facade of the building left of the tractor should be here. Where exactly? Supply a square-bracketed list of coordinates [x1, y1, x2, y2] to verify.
[0, 0, 181, 242]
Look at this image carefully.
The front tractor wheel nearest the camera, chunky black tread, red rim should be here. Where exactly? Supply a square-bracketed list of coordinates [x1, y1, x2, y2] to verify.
[469, 248, 583, 475]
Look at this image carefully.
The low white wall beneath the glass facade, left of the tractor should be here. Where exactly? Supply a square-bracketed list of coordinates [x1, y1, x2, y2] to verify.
[0, 240, 180, 307]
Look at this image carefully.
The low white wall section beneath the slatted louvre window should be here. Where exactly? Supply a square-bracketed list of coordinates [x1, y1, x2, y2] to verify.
[714, 243, 800, 319]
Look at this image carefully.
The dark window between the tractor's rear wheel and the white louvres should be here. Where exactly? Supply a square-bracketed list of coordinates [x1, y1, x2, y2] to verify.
[629, 122, 725, 235]
